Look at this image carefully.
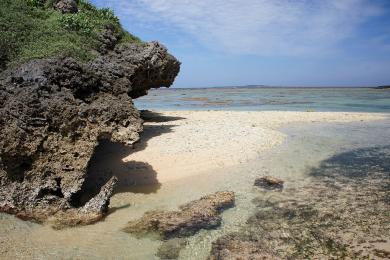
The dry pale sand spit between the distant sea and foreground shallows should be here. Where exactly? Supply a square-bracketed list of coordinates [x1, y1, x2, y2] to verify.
[123, 111, 386, 183]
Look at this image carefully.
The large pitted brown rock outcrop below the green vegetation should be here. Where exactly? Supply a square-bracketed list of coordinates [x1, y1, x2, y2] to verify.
[0, 42, 180, 225]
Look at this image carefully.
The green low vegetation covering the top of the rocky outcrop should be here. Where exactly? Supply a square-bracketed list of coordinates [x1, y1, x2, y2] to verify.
[0, 0, 141, 70]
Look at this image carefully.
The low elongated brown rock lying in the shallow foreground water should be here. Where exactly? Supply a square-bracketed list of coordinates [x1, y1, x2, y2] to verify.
[124, 191, 234, 239]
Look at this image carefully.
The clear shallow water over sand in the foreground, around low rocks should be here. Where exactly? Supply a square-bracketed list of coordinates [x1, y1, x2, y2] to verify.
[0, 117, 390, 259]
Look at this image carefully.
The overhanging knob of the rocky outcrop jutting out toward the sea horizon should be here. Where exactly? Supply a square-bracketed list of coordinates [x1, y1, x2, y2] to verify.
[90, 42, 180, 98]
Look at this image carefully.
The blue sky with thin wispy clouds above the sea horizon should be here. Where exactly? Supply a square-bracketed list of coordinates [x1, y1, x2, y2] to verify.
[91, 0, 390, 87]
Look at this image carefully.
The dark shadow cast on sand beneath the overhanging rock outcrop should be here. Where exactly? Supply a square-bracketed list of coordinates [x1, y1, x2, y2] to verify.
[74, 111, 184, 208]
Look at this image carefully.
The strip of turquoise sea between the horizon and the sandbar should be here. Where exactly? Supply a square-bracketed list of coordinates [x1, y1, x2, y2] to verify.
[135, 87, 390, 112]
